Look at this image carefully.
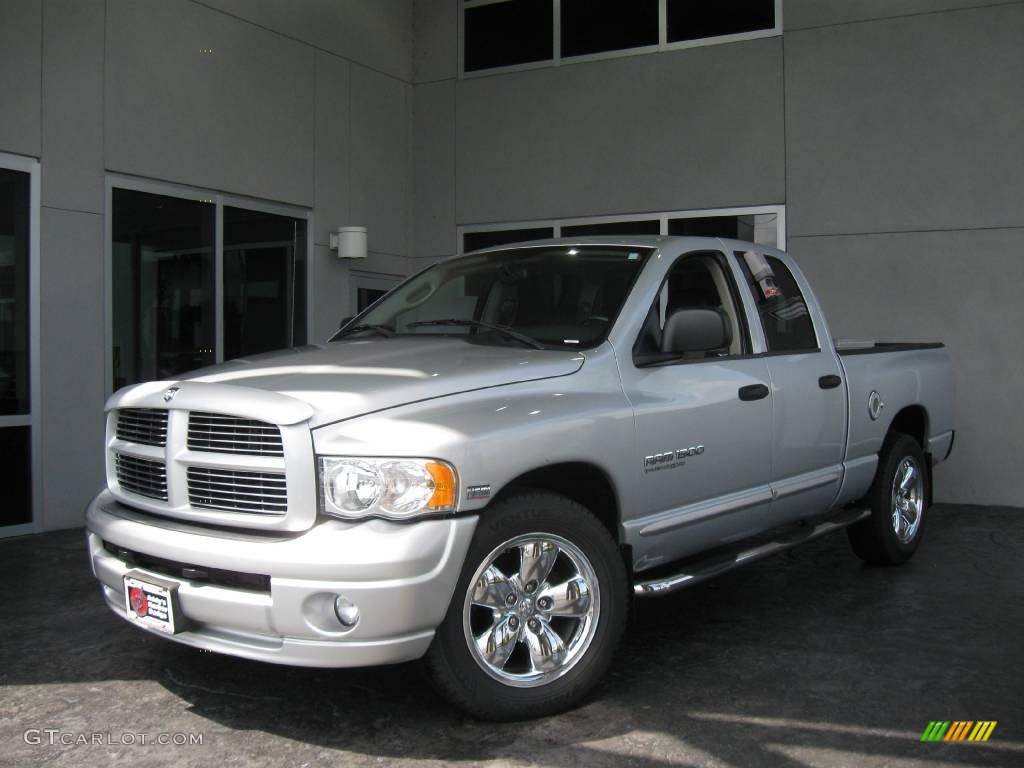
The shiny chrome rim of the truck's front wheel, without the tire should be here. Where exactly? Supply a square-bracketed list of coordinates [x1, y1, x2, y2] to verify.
[463, 534, 601, 688]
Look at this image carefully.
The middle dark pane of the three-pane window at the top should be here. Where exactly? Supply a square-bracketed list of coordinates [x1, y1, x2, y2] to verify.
[561, 0, 657, 56]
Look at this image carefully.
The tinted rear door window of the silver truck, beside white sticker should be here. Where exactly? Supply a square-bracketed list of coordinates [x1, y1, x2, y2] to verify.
[736, 253, 818, 352]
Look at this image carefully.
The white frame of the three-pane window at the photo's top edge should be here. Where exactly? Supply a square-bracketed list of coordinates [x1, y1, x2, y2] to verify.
[458, 0, 782, 80]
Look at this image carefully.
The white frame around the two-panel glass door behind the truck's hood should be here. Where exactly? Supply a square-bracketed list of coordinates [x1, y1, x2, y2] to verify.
[103, 173, 315, 395]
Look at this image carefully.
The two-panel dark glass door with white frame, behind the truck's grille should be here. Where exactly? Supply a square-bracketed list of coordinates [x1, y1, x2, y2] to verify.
[106, 177, 310, 391]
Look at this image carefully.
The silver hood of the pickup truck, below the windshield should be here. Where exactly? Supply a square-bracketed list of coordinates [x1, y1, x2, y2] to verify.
[168, 337, 585, 427]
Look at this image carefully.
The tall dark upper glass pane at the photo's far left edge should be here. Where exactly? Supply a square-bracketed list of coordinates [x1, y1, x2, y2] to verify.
[0, 168, 30, 416]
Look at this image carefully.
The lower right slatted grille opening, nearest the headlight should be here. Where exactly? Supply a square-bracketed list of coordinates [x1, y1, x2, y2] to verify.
[187, 467, 288, 515]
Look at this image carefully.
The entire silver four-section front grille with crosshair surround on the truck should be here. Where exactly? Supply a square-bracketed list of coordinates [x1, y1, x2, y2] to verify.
[106, 399, 317, 531]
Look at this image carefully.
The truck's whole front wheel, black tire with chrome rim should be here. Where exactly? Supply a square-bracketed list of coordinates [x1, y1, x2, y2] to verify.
[426, 493, 629, 720]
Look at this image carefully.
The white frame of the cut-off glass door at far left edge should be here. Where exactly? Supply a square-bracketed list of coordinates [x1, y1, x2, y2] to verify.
[0, 152, 43, 539]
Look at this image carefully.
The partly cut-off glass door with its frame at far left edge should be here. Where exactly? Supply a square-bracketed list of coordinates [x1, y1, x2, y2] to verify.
[0, 154, 38, 537]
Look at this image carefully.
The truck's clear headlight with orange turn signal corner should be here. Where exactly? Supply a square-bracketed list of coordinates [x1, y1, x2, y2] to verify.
[317, 456, 458, 520]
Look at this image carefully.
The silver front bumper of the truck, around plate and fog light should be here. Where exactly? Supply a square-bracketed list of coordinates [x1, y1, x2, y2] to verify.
[86, 490, 477, 667]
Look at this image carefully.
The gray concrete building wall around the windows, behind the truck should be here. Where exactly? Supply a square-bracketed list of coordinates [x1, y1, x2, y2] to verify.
[0, 0, 1024, 528]
